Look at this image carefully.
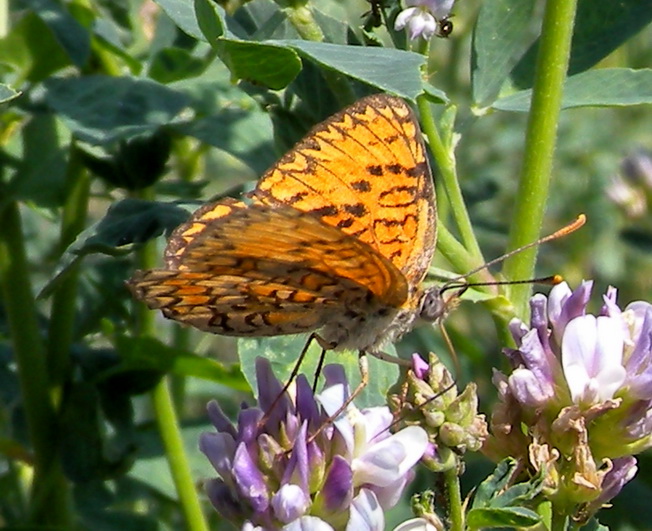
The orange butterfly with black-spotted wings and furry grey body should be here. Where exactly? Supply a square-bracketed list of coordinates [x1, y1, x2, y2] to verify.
[128, 94, 445, 354]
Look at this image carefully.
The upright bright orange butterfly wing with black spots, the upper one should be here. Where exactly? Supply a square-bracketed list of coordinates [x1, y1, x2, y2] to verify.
[254, 94, 436, 291]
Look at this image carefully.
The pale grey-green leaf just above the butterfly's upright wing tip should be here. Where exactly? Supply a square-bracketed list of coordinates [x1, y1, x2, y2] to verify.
[282, 40, 426, 101]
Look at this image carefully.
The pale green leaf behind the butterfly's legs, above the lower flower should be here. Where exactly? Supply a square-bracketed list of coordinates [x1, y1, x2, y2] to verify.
[238, 334, 399, 408]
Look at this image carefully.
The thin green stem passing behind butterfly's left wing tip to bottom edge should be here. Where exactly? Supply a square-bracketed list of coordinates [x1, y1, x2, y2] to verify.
[135, 189, 208, 531]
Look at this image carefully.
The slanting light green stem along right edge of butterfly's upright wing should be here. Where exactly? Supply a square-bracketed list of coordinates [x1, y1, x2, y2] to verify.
[417, 94, 484, 267]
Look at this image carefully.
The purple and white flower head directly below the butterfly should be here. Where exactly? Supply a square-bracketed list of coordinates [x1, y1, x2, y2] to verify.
[199, 358, 428, 531]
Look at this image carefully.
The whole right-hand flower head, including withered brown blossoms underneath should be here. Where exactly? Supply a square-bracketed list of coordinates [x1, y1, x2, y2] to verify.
[485, 282, 652, 521]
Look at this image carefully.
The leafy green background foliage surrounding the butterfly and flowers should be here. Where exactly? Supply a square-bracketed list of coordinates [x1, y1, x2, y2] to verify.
[0, 0, 652, 531]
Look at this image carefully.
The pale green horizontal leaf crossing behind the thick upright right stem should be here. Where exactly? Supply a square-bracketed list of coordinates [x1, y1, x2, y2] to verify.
[493, 68, 652, 112]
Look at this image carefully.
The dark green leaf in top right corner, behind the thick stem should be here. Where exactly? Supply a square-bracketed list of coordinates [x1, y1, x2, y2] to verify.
[512, 0, 652, 89]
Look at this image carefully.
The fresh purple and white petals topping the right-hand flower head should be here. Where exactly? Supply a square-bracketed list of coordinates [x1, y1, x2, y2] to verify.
[505, 282, 652, 407]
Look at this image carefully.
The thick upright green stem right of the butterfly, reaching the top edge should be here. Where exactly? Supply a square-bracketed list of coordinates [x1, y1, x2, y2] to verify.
[503, 0, 577, 317]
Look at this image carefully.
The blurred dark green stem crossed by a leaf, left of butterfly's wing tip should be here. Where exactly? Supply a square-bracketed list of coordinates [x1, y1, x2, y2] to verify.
[48, 143, 90, 406]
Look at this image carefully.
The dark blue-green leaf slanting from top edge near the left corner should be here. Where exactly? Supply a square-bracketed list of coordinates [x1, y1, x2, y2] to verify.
[26, 0, 91, 68]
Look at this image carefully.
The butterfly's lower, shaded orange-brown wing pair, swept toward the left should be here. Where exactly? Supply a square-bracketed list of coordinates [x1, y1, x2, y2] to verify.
[129, 201, 407, 336]
